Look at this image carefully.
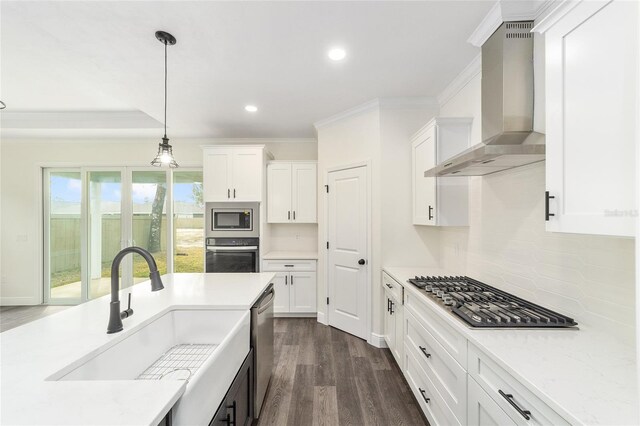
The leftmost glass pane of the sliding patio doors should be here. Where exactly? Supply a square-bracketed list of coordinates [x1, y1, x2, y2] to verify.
[45, 171, 82, 299]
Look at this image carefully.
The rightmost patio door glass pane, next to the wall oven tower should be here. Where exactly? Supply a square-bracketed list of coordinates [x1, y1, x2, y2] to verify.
[173, 170, 204, 272]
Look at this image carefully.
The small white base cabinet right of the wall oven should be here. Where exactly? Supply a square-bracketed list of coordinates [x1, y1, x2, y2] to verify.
[262, 260, 317, 314]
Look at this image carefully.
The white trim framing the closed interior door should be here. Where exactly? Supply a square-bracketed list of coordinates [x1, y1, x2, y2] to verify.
[318, 159, 372, 346]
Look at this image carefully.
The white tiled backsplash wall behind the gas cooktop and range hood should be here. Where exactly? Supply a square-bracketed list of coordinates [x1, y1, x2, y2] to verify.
[440, 53, 635, 339]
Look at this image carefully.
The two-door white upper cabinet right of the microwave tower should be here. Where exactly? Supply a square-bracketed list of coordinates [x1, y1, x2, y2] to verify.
[267, 161, 317, 223]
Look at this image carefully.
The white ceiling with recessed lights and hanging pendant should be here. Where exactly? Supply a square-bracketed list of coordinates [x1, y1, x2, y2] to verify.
[0, 1, 494, 137]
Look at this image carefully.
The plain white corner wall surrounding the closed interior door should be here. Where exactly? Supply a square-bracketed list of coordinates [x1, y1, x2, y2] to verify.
[318, 103, 439, 342]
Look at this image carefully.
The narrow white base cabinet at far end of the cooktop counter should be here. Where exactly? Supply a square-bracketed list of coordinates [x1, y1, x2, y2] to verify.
[382, 272, 404, 365]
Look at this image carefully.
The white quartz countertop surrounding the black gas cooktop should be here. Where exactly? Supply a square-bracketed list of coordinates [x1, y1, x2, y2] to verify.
[383, 267, 640, 425]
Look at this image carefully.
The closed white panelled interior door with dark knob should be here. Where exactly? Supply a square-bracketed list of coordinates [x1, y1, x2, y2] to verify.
[327, 167, 369, 339]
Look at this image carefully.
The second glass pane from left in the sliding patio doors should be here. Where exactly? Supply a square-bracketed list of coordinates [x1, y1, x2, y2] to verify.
[87, 171, 122, 299]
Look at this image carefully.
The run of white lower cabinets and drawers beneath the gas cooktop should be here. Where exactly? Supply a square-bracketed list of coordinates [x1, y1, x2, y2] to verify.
[382, 273, 570, 426]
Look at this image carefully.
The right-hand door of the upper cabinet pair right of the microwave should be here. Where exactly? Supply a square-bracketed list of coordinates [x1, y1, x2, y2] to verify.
[291, 163, 318, 223]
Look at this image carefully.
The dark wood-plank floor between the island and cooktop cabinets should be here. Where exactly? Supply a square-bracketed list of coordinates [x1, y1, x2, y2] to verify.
[258, 318, 428, 426]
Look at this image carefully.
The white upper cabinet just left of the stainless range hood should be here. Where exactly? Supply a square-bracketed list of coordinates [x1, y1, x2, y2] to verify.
[411, 118, 472, 226]
